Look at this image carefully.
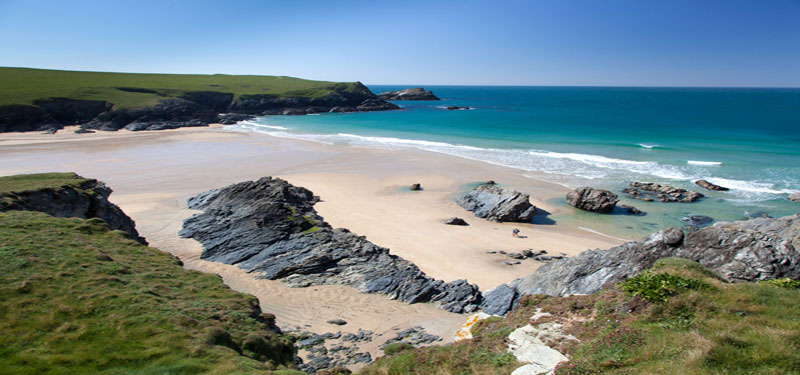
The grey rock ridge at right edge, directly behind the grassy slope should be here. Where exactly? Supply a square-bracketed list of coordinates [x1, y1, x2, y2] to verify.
[509, 215, 800, 308]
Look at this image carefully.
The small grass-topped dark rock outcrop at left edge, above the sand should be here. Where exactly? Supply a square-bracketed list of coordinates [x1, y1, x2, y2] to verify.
[0, 173, 147, 245]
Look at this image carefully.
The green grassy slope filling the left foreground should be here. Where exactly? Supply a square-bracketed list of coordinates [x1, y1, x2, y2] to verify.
[0, 210, 294, 375]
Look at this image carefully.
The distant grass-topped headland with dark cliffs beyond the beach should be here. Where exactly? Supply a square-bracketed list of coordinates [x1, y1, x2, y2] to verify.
[0, 68, 398, 132]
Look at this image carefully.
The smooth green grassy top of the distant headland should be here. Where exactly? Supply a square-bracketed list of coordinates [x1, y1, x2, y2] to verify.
[0, 67, 356, 109]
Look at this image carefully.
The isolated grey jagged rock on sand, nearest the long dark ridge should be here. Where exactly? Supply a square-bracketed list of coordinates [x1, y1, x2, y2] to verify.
[456, 184, 536, 223]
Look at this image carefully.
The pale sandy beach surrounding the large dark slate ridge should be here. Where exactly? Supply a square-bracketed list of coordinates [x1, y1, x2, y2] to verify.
[0, 127, 622, 366]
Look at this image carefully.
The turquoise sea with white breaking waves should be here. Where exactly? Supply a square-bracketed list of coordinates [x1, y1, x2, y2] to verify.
[227, 86, 800, 238]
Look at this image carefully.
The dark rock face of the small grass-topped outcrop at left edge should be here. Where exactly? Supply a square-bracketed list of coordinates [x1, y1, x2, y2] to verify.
[0, 175, 147, 245]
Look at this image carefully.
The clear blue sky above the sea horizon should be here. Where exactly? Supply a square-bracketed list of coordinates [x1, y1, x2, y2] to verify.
[0, 0, 800, 87]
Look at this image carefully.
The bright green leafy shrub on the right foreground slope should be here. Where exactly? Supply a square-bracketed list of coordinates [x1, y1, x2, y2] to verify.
[620, 271, 711, 302]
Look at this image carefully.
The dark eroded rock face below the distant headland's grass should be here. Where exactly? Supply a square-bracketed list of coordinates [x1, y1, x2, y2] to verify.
[0, 83, 399, 132]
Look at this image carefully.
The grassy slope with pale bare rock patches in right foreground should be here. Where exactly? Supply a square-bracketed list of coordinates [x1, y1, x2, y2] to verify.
[361, 258, 800, 375]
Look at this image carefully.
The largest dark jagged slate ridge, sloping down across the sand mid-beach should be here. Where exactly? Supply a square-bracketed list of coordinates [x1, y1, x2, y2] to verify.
[180, 177, 481, 313]
